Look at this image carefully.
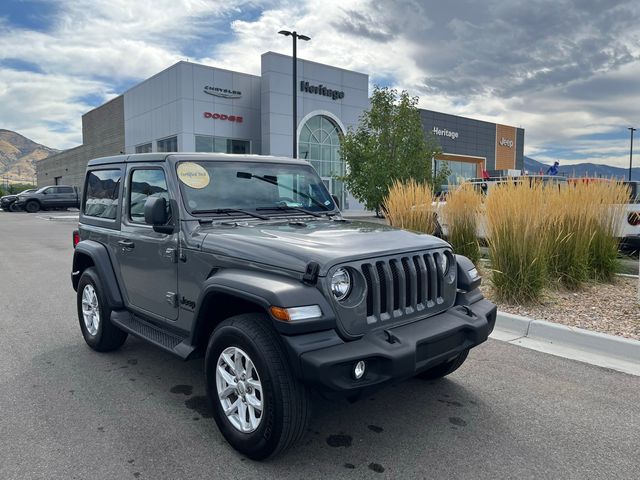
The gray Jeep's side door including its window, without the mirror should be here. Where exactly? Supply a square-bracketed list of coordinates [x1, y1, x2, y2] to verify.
[117, 165, 178, 320]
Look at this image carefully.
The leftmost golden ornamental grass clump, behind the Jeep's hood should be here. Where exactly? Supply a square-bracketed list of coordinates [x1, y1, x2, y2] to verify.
[383, 180, 436, 235]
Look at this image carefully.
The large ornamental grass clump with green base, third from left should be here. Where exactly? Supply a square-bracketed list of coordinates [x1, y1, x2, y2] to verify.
[486, 182, 549, 303]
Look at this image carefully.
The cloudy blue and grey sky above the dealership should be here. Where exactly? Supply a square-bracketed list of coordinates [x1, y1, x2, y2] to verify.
[0, 0, 640, 166]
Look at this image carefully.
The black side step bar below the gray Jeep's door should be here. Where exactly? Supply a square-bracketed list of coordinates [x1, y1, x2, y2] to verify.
[111, 310, 195, 360]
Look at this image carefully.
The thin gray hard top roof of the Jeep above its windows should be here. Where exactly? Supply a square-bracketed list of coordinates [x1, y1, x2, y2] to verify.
[87, 152, 309, 167]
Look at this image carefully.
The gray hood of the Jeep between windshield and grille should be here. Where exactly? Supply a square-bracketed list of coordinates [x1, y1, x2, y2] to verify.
[199, 219, 447, 276]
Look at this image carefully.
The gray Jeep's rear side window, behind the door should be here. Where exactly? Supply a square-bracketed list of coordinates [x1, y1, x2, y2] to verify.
[83, 170, 120, 220]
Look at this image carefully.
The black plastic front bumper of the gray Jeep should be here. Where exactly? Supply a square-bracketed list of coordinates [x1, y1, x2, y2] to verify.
[283, 299, 497, 394]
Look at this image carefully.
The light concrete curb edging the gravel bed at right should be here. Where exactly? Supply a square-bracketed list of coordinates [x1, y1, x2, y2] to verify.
[492, 311, 640, 375]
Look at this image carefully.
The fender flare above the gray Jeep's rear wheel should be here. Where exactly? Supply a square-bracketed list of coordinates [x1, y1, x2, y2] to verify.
[71, 240, 124, 309]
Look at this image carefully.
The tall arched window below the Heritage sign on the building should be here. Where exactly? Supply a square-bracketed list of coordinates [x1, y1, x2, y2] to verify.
[298, 115, 348, 208]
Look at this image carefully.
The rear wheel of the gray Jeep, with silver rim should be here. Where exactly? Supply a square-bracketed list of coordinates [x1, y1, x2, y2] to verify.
[77, 267, 127, 352]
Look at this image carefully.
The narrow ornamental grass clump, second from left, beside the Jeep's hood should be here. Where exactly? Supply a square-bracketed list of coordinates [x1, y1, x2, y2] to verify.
[442, 183, 482, 264]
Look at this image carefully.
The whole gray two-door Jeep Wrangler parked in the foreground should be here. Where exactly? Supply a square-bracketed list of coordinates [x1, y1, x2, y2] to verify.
[71, 153, 496, 459]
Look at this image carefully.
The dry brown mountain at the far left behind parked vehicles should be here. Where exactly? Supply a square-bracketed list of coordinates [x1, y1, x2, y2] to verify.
[0, 129, 59, 183]
